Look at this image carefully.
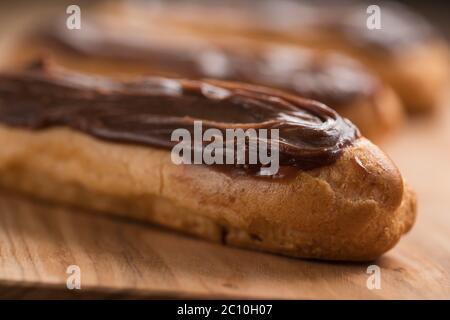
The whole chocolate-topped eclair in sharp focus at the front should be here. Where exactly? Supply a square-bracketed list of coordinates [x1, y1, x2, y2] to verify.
[0, 64, 416, 261]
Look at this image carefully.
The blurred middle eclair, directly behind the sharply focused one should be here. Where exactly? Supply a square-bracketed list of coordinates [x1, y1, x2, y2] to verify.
[4, 4, 404, 141]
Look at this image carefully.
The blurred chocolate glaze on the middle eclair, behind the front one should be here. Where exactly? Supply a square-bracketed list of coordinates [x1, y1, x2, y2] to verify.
[39, 15, 379, 109]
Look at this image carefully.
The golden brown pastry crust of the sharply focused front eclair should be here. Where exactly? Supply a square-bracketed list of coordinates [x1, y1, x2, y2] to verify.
[0, 126, 415, 260]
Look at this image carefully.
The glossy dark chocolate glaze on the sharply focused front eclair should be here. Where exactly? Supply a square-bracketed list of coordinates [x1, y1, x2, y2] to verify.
[0, 65, 359, 169]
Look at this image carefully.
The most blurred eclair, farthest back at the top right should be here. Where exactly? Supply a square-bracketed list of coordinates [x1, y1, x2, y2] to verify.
[134, 0, 450, 113]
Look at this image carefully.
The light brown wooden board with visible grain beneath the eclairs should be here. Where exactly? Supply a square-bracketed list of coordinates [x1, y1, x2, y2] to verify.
[0, 1, 450, 299]
